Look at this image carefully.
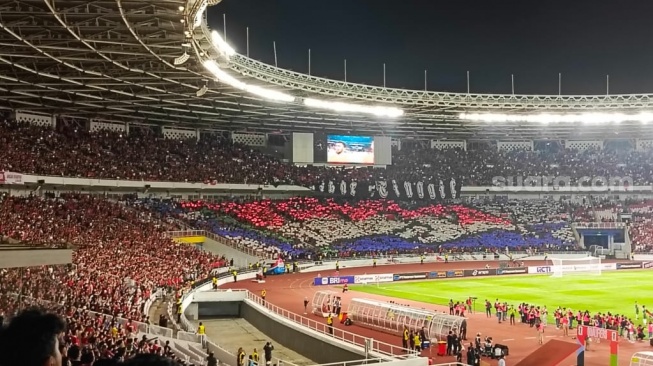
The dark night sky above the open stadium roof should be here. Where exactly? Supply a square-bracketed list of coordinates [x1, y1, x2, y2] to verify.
[208, 0, 653, 94]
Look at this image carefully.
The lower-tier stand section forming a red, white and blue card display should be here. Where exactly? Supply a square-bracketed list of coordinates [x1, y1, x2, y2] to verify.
[148, 197, 575, 258]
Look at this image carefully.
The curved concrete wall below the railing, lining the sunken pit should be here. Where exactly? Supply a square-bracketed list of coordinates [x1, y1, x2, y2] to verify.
[241, 301, 362, 364]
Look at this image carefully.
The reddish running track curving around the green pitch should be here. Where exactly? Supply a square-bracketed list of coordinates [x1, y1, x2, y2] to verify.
[222, 261, 652, 366]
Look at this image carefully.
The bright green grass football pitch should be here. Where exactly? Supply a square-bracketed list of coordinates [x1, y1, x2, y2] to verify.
[349, 270, 653, 319]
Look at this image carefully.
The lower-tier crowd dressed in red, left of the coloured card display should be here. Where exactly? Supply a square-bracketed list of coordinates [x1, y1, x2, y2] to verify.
[0, 195, 220, 364]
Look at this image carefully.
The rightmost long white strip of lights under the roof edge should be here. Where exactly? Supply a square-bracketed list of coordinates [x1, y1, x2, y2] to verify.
[458, 112, 653, 124]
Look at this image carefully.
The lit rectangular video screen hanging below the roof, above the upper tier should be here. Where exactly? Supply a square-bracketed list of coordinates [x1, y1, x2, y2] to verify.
[327, 135, 374, 164]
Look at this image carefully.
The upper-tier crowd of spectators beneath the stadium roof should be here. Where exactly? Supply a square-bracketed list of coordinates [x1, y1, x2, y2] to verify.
[0, 121, 653, 186]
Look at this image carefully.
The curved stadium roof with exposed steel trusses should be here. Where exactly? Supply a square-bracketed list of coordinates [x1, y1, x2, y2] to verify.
[0, 0, 653, 140]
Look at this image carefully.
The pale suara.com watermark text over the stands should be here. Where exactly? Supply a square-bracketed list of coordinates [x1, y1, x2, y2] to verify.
[492, 175, 633, 192]
